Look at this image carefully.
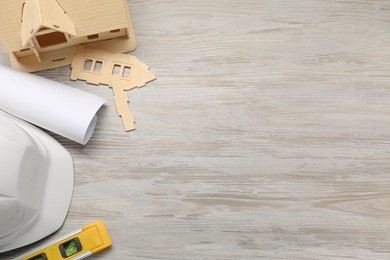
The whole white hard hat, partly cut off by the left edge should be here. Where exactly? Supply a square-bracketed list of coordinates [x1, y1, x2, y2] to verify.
[0, 111, 73, 253]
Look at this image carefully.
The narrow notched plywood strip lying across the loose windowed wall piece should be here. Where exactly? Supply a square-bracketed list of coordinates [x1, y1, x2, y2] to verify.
[110, 75, 135, 131]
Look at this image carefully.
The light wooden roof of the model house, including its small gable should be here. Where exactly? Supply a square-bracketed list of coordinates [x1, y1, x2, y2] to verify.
[0, 0, 130, 52]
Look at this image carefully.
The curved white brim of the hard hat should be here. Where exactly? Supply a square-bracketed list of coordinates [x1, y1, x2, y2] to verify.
[0, 111, 74, 253]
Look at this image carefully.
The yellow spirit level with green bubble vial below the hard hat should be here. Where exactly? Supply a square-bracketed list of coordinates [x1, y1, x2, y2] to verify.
[14, 220, 112, 260]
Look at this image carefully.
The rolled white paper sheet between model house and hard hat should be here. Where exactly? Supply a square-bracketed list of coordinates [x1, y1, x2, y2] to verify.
[0, 65, 104, 145]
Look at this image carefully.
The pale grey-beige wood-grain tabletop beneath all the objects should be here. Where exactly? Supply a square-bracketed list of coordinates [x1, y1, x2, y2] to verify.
[0, 0, 390, 260]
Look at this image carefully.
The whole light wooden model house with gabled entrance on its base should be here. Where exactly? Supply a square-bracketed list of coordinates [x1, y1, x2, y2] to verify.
[0, 0, 136, 72]
